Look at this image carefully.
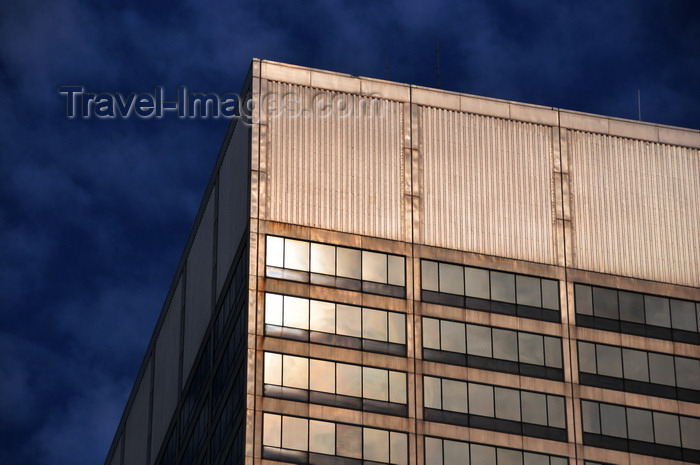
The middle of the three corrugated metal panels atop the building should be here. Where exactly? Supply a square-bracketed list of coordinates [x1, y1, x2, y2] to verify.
[420, 107, 557, 264]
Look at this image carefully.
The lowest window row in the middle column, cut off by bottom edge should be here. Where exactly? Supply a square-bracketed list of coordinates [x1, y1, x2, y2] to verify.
[425, 437, 569, 465]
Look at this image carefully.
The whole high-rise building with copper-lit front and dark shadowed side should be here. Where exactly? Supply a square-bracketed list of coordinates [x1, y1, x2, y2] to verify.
[105, 60, 700, 465]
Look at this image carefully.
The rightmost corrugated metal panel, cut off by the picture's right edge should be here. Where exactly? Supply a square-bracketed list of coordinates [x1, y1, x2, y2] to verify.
[569, 131, 700, 286]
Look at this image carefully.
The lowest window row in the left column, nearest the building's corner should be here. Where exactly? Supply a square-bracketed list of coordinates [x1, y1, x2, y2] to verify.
[263, 413, 408, 465]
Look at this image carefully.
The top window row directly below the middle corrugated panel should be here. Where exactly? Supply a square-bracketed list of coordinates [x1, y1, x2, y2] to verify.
[421, 260, 561, 321]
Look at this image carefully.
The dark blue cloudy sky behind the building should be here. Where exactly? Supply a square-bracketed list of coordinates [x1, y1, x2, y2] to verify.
[0, 0, 700, 465]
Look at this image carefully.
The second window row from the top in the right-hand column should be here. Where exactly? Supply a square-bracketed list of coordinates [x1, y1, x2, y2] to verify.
[578, 341, 700, 402]
